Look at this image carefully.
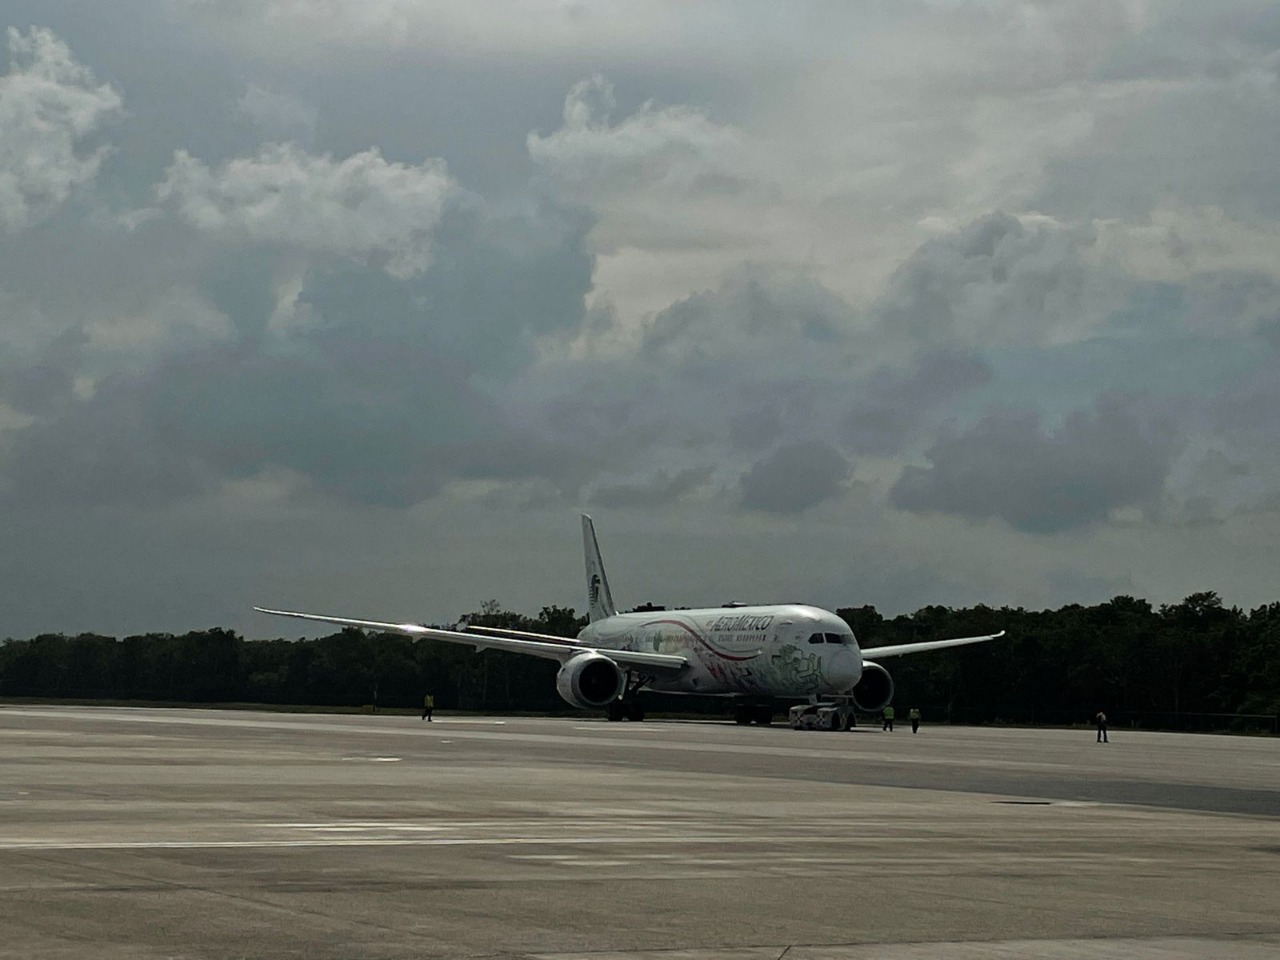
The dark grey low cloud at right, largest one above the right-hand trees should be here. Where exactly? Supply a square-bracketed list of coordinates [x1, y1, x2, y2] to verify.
[890, 397, 1179, 534]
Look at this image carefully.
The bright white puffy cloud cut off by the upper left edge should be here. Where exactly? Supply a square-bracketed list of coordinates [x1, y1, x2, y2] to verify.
[0, 27, 122, 233]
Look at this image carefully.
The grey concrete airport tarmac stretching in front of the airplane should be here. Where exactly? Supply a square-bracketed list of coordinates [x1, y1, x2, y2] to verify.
[0, 707, 1280, 960]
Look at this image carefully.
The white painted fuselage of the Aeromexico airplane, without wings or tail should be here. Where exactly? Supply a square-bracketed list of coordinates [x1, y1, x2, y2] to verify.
[579, 604, 863, 696]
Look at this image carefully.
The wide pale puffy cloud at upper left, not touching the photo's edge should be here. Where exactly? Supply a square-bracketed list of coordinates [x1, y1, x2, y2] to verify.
[156, 143, 463, 278]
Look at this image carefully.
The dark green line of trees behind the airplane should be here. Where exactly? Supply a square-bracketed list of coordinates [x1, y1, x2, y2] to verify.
[0, 593, 1280, 732]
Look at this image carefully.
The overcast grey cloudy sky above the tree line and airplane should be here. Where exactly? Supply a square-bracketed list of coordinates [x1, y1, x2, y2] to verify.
[0, 0, 1280, 637]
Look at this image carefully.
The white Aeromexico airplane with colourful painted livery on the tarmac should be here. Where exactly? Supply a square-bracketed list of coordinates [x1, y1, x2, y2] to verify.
[253, 513, 1005, 724]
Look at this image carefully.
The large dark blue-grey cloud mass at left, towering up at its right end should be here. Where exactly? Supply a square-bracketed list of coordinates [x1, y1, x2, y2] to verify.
[0, 185, 591, 506]
